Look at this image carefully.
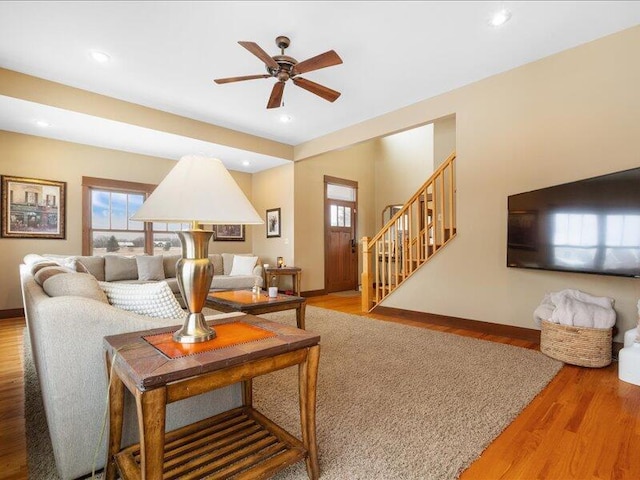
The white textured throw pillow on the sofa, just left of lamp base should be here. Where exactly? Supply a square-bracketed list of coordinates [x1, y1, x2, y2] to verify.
[98, 282, 186, 319]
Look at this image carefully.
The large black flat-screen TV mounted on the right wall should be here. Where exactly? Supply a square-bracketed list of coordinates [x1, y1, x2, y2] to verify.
[507, 168, 640, 277]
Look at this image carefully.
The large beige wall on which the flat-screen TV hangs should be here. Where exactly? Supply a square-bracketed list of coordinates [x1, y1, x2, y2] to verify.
[370, 27, 640, 341]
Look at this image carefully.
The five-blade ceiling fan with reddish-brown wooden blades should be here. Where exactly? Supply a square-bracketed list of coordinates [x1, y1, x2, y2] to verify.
[214, 35, 342, 108]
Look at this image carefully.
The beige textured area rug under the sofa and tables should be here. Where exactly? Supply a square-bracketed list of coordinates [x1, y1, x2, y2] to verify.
[25, 307, 562, 480]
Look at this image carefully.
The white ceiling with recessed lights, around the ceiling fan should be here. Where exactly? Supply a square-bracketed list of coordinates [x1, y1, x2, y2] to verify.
[0, 1, 640, 171]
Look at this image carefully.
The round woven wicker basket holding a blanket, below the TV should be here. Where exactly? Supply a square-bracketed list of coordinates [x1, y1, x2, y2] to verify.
[540, 320, 613, 368]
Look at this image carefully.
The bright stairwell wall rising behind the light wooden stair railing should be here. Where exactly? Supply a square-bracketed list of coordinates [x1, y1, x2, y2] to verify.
[371, 124, 434, 231]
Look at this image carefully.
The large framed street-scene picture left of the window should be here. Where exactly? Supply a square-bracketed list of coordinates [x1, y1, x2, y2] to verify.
[2, 175, 67, 239]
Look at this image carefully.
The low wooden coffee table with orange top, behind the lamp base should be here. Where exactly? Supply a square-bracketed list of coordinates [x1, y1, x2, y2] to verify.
[206, 290, 307, 330]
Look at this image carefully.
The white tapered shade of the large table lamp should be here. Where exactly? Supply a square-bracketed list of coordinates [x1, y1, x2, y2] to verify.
[131, 155, 264, 225]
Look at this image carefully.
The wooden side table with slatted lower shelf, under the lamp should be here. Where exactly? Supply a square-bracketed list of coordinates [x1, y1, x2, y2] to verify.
[104, 315, 320, 480]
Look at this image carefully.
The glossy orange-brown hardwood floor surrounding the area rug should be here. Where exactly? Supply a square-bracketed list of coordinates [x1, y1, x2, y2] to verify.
[0, 295, 640, 480]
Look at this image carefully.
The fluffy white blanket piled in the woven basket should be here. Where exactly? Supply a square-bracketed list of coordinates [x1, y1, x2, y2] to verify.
[533, 289, 616, 328]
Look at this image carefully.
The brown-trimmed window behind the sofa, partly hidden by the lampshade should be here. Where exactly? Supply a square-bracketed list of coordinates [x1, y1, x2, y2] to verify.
[82, 177, 188, 255]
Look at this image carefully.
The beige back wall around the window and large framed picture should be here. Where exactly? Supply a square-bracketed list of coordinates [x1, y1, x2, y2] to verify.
[0, 131, 252, 310]
